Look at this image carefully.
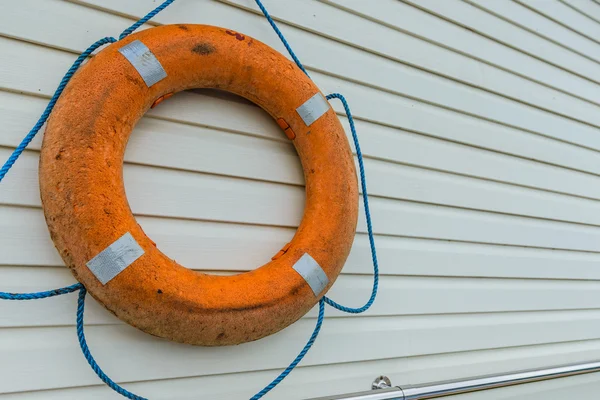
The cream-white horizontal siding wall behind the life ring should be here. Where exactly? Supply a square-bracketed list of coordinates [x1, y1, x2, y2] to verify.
[0, 0, 600, 400]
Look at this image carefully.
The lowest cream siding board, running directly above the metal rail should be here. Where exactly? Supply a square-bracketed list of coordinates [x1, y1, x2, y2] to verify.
[0, 341, 600, 400]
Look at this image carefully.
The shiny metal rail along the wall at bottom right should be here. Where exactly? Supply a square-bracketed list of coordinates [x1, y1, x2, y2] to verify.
[312, 361, 600, 400]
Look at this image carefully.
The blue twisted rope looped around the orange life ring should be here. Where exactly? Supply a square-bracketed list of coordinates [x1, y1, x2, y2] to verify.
[0, 0, 379, 400]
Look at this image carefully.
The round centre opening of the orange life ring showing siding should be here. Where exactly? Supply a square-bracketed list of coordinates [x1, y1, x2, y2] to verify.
[123, 89, 305, 275]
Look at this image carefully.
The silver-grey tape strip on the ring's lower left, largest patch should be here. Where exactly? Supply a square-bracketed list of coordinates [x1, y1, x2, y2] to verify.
[86, 232, 144, 285]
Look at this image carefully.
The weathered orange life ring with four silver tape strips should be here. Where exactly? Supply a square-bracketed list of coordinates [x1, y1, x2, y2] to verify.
[40, 25, 358, 345]
